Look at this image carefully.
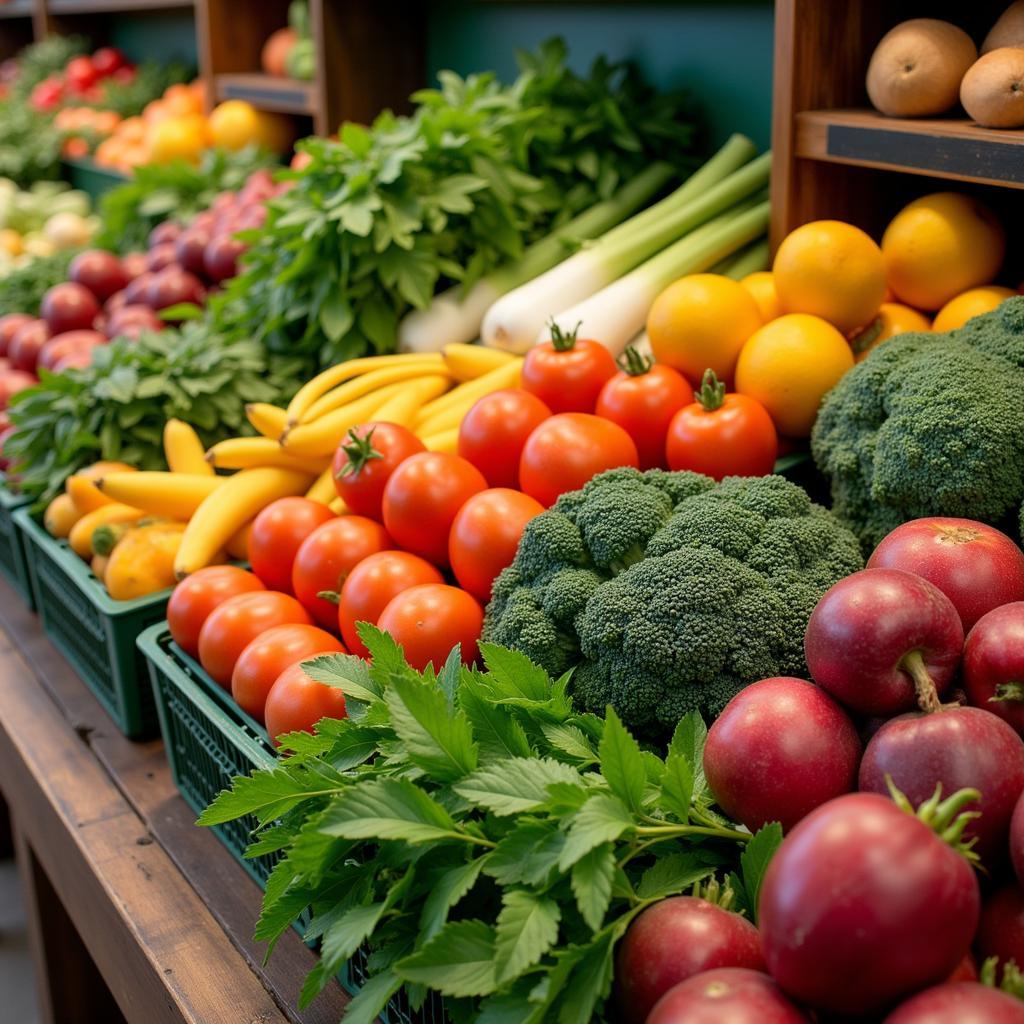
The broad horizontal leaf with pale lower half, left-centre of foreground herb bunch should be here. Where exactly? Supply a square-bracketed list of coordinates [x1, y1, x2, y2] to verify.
[319, 778, 457, 843]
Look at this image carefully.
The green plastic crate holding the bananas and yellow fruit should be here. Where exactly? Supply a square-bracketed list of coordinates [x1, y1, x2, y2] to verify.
[14, 508, 165, 739]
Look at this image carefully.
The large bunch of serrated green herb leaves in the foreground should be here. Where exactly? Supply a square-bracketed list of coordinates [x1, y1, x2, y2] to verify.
[200, 624, 781, 1024]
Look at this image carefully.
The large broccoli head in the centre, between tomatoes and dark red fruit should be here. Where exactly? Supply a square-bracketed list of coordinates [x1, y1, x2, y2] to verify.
[483, 469, 863, 741]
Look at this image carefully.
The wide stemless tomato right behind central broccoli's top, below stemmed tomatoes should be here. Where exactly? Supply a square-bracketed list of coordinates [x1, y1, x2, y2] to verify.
[519, 413, 640, 506]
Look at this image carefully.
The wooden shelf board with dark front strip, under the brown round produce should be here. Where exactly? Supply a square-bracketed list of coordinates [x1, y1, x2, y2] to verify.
[795, 110, 1024, 188]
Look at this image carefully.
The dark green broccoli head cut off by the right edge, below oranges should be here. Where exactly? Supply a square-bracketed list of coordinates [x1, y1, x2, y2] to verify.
[811, 297, 1024, 550]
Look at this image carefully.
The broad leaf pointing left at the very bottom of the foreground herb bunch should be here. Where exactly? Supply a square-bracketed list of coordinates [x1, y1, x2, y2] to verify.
[394, 921, 496, 996]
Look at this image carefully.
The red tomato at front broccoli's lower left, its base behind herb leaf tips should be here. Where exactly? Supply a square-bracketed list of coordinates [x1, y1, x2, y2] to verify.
[377, 583, 483, 671]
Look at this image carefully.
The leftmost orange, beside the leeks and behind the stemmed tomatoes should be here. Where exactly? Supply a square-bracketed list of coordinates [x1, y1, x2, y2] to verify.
[647, 273, 762, 381]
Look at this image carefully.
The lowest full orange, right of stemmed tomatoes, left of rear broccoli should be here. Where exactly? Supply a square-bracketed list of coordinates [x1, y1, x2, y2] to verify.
[736, 313, 853, 437]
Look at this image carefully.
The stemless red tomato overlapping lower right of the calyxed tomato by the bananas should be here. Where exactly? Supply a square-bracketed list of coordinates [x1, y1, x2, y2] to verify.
[383, 452, 487, 565]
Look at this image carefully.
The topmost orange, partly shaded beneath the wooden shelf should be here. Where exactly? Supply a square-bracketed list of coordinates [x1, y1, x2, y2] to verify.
[882, 193, 1007, 309]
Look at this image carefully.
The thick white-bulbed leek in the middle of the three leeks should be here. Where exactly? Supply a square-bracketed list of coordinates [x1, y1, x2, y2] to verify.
[480, 135, 768, 352]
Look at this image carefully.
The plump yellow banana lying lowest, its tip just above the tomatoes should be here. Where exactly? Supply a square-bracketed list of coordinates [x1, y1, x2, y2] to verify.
[174, 466, 309, 580]
